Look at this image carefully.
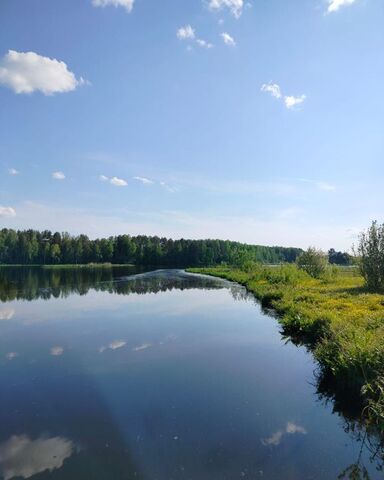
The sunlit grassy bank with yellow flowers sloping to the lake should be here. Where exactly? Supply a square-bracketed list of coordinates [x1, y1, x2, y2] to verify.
[188, 265, 384, 433]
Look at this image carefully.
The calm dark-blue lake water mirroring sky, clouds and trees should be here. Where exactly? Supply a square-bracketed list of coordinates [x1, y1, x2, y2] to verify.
[0, 269, 383, 480]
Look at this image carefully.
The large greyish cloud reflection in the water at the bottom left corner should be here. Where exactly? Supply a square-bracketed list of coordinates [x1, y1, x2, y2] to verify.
[0, 435, 74, 480]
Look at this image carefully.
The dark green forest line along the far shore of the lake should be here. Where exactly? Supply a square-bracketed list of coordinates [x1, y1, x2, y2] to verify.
[0, 228, 302, 267]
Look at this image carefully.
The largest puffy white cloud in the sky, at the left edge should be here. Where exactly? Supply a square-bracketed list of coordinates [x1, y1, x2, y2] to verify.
[0, 50, 87, 95]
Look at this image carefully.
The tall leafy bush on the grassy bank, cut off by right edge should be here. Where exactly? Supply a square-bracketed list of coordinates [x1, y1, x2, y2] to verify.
[357, 221, 384, 291]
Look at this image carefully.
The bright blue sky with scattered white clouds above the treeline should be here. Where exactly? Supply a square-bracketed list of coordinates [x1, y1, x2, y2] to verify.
[0, 0, 384, 250]
